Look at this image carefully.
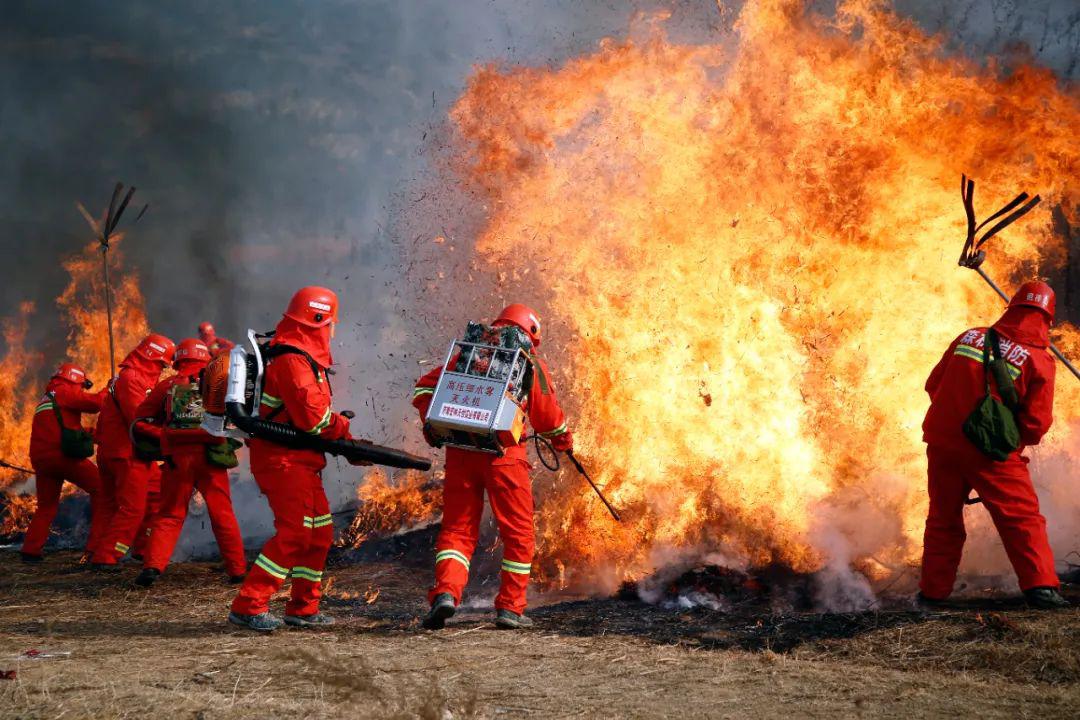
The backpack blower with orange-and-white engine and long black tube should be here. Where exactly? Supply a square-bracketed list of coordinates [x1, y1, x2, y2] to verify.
[201, 330, 431, 471]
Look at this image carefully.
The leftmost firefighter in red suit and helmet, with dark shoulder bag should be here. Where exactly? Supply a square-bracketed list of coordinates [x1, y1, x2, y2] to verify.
[22, 363, 103, 562]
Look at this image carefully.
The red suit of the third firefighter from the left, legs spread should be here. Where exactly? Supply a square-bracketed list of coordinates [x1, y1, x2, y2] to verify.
[136, 361, 247, 576]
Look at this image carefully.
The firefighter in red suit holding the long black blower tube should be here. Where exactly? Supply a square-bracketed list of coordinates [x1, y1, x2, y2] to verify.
[229, 287, 351, 631]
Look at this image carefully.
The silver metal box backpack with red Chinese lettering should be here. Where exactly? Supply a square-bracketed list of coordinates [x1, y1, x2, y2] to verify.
[424, 323, 534, 456]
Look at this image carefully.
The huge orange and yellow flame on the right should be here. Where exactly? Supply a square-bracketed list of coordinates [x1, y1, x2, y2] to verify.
[440, 0, 1080, 586]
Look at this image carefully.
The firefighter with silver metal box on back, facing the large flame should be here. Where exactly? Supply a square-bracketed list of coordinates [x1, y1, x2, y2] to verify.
[413, 304, 573, 629]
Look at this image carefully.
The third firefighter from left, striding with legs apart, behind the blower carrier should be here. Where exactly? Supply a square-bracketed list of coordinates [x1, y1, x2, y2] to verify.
[135, 338, 247, 587]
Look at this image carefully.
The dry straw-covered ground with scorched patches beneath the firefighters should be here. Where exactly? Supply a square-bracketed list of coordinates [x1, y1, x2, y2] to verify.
[0, 551, 1080, 720]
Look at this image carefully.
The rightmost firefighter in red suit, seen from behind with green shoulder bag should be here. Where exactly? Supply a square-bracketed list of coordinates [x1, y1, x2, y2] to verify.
[919, 282, 1066, 608]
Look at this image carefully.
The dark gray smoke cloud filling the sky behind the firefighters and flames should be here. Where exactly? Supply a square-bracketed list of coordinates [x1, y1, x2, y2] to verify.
[0, 0, 1080, 569]
